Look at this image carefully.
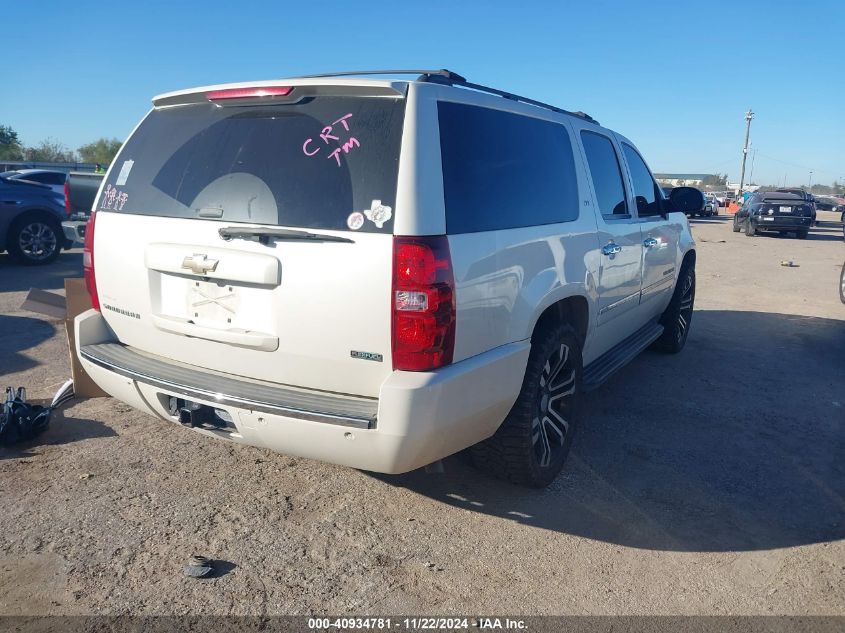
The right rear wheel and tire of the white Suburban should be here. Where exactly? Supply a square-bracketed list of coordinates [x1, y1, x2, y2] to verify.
[470, 324, 583, 488]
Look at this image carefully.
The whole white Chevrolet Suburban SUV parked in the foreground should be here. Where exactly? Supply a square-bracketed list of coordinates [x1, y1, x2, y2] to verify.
[76, 71, 703, 486]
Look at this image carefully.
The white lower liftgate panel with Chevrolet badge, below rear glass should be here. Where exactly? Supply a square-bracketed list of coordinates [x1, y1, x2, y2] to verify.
[95, 212, 393, 396]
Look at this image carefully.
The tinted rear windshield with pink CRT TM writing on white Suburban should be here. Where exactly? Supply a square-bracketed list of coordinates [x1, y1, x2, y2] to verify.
[98, 96, 405, 233]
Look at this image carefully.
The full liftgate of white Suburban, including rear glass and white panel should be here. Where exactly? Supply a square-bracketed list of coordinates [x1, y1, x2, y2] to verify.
[94, 87, 404, 397]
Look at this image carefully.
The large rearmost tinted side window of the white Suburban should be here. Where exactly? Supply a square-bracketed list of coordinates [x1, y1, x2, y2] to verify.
[438, 102, 578, 234]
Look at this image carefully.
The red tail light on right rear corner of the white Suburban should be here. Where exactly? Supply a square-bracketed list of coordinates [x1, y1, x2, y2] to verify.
[392, 235, 455, 371]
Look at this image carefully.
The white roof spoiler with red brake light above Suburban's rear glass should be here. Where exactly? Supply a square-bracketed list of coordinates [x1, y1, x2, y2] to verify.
[153, 79, 408, 108]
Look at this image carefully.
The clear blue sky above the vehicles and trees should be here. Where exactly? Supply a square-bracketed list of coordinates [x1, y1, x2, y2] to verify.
[0, 0, 845, 184]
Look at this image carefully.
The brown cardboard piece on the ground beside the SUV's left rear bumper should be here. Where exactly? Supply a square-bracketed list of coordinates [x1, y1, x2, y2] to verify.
[21, 277, 108, 398]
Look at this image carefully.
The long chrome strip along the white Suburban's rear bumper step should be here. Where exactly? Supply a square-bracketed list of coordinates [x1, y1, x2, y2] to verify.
[79, 346, 376, 429]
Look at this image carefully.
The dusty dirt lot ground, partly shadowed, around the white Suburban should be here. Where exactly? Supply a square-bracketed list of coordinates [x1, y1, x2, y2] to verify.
[0, 212, 845, 615]
